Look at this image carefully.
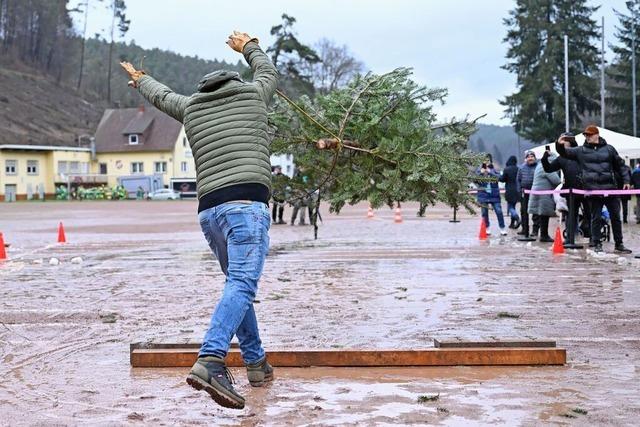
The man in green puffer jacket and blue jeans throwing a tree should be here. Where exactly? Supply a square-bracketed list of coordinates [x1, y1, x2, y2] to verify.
[121, 31, 278, 409]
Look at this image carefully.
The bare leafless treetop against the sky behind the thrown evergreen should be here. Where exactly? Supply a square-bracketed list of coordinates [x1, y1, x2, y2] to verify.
[308, 39, 364, 93]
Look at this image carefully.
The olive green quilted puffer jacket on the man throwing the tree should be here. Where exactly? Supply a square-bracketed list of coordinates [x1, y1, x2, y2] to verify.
[138, 42, 278, 199]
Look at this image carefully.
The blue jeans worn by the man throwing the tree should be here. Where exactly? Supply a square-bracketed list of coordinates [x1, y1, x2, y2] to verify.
[198, 202, 271, 364]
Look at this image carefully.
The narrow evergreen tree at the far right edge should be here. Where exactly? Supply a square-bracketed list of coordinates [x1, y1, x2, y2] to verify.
[607, 0, 640, 135]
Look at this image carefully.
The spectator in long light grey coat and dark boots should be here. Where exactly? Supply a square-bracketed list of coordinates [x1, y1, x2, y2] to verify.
[529, 151, 562, 243]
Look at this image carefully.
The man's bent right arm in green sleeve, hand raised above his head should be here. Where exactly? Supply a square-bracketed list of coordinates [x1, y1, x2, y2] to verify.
[227, 31, 278, 104]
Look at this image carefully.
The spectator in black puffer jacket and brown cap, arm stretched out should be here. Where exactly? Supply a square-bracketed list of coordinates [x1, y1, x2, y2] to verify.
[557, 126, 631, 254]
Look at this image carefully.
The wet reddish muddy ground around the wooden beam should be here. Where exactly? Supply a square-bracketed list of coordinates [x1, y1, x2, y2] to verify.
[0, 201, 640, 426]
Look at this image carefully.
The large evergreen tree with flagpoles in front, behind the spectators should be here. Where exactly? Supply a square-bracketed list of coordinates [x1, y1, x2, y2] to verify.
[501, 0, 599, 142]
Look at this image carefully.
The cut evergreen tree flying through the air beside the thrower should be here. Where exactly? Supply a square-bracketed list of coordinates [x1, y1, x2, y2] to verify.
[270, 68, 480, 217]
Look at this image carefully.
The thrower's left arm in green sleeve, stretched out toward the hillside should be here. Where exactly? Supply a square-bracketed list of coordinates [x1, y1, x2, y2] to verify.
[120, 62, 189, 122]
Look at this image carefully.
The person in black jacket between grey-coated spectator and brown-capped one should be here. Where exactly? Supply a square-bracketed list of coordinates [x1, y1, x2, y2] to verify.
[542, 132, 591, 241]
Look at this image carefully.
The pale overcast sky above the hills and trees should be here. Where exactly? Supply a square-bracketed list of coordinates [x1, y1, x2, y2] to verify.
[70, 0, 625, 124]
